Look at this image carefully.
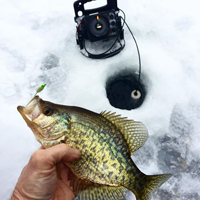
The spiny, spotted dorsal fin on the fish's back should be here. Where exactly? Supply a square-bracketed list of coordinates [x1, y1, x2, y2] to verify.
[100, 111, 148, 154]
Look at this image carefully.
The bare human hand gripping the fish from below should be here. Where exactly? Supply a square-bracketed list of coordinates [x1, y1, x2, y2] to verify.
[11, 144, 80, 200]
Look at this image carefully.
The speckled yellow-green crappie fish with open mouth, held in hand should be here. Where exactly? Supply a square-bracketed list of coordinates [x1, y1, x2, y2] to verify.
[17, 96, 171, 200]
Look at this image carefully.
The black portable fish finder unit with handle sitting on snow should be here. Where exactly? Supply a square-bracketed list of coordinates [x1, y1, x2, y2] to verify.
[74, 0, 125, 59]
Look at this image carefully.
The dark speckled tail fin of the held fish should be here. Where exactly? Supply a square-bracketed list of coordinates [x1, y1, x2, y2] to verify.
[132, 174, 172, 200]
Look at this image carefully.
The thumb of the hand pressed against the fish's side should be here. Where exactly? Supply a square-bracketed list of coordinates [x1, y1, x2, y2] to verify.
[44, 144, 80, 165]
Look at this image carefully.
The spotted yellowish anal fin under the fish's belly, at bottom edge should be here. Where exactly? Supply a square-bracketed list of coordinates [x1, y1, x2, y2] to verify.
[78, 185, 127, 200]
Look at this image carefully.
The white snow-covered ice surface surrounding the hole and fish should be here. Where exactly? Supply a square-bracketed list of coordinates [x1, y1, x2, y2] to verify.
[0, 0, 200, 200]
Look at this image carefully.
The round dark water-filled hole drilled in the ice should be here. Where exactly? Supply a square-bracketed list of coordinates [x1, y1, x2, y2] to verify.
[106, 71, 146, 110]
